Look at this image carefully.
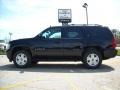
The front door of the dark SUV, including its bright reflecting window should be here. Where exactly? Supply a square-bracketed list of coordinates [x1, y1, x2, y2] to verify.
[35, 27, 63, 56]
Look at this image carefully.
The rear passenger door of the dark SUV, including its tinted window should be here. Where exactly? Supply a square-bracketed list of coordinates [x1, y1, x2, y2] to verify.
[63, 27, 84, 56]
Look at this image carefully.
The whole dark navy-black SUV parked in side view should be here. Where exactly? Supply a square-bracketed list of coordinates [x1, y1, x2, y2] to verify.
[7, 25, 117, 68]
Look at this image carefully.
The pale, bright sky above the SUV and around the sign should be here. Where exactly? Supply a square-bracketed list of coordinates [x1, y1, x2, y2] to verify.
[0, 0, 120, 40]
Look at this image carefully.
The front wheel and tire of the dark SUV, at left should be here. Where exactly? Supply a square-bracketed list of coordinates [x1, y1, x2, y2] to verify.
[13, 50, 31, 68]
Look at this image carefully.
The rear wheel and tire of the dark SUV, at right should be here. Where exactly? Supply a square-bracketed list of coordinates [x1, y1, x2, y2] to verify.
[83, 49, 102, 69]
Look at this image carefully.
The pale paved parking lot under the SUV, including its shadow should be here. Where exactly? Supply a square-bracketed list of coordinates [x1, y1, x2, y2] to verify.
[0, 55, 120, 90]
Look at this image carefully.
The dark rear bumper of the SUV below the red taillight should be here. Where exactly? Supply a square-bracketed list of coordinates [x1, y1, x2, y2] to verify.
[104, 48, 117, 58]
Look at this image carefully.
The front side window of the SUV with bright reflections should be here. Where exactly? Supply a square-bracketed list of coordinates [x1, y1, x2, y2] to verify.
[42, 28, 61, 38]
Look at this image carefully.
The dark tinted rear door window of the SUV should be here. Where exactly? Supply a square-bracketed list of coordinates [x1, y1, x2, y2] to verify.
[63, 27, 83, 39]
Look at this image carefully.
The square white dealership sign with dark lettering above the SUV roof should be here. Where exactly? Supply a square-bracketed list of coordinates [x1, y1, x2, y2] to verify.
[58, 9, 72, 23]
